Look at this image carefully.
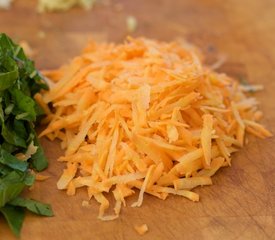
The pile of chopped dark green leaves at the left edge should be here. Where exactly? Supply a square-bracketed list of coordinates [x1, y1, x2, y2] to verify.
[0, 34, 53, 236]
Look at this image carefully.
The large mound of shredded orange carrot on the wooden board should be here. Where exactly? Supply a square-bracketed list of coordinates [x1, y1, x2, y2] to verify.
[36, 38, 271, 220]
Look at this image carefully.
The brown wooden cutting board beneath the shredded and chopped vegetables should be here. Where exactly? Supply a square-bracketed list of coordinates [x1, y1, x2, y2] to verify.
[0, 0, 275, 240]
